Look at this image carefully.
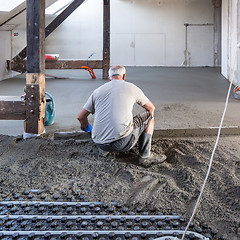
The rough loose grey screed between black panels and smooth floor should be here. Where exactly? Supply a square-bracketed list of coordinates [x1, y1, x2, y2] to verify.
[0, 135, 240, 239]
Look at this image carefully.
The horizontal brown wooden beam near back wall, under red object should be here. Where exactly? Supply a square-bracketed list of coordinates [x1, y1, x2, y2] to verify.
[8, 60, 103, 73]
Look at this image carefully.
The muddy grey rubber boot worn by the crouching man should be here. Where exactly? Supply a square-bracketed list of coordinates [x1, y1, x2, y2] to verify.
[138, 132, 167, 167]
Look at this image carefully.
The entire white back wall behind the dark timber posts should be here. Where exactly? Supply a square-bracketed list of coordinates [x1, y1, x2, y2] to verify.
[8, 0, 214, 66]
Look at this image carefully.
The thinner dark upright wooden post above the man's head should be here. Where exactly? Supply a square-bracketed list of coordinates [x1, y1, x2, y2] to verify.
[103, 0, 110, 79]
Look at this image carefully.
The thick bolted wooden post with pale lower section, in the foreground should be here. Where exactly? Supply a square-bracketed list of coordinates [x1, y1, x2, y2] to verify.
[25, 0, 45, 134]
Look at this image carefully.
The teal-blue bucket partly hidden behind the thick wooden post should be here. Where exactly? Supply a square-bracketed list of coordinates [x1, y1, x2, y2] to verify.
[44, 92, 55, 126]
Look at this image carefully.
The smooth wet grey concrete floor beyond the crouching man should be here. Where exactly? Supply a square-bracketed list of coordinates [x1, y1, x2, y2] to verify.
[0, 67, 240, 135]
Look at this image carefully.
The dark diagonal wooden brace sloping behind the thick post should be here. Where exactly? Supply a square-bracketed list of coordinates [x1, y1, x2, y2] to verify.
[12, 0, 85, 62]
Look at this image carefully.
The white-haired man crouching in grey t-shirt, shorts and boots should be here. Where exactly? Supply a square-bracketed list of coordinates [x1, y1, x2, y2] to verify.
[78, 66, 166, 166]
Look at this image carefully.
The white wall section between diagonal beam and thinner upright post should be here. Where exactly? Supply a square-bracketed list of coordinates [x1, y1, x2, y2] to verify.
[46, 0, 103, 59]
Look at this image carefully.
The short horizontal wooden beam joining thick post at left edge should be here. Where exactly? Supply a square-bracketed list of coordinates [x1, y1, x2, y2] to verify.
[0, 96, 26, 120]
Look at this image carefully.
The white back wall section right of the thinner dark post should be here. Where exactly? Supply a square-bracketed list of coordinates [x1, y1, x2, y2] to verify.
[111, 0, 214, 66]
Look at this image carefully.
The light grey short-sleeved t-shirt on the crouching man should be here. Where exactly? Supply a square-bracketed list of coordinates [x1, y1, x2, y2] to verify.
[83, 79, 149, 144]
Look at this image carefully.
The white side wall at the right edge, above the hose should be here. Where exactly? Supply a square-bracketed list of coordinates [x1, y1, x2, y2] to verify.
[222, 0, 240, 85]
